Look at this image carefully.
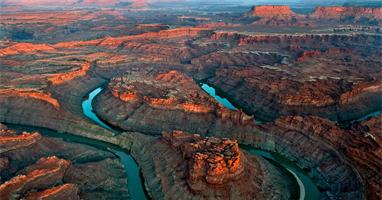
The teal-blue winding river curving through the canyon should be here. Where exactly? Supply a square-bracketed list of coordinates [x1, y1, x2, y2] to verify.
[6, 84, 320, 200]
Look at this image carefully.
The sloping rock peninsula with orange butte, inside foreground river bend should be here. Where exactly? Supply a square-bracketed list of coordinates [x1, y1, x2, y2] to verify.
[132, 131, 298, 199]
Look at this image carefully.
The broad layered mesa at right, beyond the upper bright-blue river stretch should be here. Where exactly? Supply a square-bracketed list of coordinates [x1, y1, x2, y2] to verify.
[203, 41, 382, 121]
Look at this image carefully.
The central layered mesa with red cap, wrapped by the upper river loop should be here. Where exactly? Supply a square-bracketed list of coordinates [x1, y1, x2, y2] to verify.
[93, 69, 253, 134]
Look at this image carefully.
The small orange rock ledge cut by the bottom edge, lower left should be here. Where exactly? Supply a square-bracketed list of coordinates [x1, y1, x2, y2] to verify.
[22, 183, 81, 200]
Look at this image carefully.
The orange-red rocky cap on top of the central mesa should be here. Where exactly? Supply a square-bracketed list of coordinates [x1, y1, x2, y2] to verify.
[109, 71, 212, 113]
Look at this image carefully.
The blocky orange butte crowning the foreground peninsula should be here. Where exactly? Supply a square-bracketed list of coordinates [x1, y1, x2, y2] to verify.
[182, 134, 244, 185]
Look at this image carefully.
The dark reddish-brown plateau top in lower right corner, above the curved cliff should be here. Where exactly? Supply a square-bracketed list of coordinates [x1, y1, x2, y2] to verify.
[275, 116, 382, 199]
